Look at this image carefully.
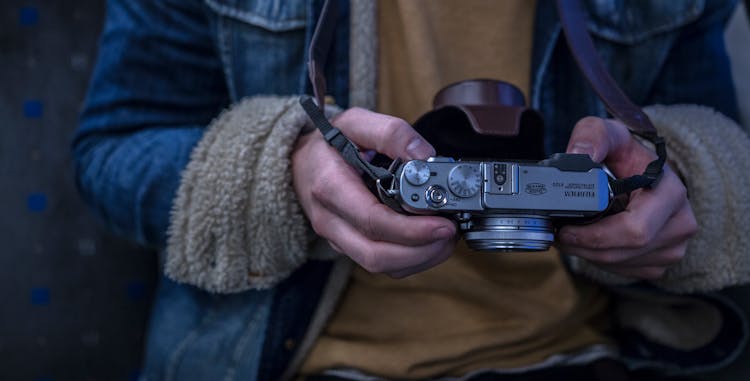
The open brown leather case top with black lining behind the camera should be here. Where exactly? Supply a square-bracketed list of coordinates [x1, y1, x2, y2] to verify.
[414, 79, 544, 160]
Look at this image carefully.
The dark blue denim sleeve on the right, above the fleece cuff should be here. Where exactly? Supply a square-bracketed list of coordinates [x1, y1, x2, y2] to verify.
[645, 0, 739, 121]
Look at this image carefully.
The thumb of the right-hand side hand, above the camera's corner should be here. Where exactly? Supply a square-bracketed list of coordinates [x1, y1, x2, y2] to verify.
[566, 117, 656, 177]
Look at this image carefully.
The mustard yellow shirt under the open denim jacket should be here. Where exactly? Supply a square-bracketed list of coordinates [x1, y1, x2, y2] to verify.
[302, 0, 607, 379]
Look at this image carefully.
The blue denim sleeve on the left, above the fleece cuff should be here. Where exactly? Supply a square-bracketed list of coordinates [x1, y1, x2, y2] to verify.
[73, 0, 229, 247]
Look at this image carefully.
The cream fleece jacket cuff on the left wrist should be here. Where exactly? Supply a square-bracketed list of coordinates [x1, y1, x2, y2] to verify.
[164, 96, 314, 293]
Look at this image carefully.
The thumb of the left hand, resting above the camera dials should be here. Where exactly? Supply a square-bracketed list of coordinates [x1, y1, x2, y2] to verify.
[332, 108, 435, 160]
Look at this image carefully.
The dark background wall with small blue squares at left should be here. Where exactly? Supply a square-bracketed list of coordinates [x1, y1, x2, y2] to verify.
[0, 0, 156, 381]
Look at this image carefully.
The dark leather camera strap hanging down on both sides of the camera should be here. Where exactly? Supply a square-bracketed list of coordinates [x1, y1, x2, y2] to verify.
[300, 0, 667, 195]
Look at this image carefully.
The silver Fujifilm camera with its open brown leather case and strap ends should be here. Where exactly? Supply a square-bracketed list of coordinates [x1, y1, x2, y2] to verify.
[302, 79, 636, 252]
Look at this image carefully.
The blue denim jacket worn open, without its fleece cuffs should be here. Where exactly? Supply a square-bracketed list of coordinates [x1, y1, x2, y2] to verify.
[73, 0, 737, 380]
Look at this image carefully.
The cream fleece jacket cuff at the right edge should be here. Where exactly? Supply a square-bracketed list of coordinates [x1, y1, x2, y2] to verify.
[572, 105, 750, 293]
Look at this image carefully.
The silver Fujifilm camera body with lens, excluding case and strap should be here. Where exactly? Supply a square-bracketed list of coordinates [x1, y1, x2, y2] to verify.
[381, 154, 613, 251]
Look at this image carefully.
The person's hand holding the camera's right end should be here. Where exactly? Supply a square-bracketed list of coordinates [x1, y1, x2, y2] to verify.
[558, 117, 698, 279]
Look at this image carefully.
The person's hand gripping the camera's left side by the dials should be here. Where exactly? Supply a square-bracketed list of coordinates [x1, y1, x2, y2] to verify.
[292, 108, 456, 277]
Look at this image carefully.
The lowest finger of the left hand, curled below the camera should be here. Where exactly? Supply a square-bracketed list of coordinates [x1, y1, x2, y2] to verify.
[325, 211, 453, 273]
